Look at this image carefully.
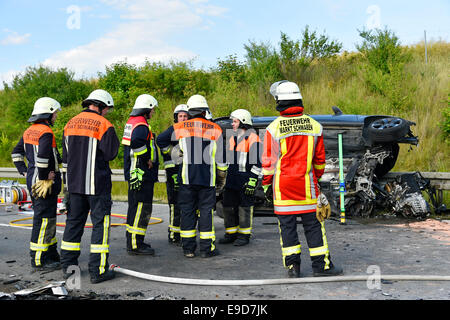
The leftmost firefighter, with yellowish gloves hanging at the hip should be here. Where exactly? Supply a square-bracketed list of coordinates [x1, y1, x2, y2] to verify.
[11, 97, 61, 270]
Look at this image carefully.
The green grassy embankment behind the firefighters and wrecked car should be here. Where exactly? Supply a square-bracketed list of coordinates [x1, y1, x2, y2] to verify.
[0, 42, 450, 206]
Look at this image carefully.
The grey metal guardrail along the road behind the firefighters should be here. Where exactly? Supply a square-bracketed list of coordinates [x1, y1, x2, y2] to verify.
[0, 168, 450, 190]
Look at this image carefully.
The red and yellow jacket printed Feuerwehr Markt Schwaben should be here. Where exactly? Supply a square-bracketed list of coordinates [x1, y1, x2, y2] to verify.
[262, 114, 325, 214]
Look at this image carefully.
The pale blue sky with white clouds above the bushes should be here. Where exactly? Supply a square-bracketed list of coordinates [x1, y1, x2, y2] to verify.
[0, 0, 450, 89]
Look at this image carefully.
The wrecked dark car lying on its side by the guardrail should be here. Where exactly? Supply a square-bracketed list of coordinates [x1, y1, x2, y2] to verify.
[214, 107, 430, 217]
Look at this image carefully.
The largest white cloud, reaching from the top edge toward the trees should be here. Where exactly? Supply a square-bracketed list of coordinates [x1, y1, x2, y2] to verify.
[43, 0, 227, 76]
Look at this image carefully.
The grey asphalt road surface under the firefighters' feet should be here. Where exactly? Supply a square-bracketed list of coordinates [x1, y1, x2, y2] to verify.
[0, 202, 450, 302]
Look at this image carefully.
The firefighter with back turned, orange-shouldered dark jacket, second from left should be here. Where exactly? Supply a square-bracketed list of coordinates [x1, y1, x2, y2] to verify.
[61, 89, 119, 283]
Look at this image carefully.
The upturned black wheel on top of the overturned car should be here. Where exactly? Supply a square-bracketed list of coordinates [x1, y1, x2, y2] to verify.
[368, 117, 409, 143]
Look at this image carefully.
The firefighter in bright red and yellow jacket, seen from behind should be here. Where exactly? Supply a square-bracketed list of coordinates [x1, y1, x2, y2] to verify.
[262, 80, 343, 277]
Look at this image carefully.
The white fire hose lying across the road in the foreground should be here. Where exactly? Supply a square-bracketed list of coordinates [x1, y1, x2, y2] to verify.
[110, 265, 450, 286]
